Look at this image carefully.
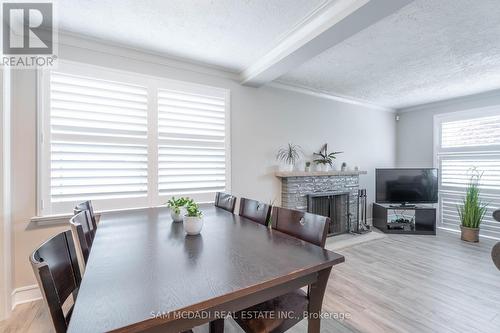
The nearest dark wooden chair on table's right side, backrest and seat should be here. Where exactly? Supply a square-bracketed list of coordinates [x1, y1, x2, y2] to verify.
[234, 207, 330, 333]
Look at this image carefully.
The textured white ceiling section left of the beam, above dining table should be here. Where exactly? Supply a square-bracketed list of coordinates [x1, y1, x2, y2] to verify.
[57, 0, 325, 71]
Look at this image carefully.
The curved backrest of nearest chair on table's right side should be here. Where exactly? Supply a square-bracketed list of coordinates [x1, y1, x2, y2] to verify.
[272, 207, 330, 248]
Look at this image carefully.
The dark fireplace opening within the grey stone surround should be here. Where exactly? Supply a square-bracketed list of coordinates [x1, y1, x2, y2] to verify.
[307, 192, 351, 236]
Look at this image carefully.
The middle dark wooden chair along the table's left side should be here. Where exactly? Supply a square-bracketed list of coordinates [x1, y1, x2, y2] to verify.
[69, 210, 94, 269]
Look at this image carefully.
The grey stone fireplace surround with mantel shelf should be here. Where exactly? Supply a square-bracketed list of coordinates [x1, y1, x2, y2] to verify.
[275, 171, 367, 230]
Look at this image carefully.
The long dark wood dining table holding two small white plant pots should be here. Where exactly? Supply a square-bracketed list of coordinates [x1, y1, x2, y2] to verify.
[68, 205, 344, 333]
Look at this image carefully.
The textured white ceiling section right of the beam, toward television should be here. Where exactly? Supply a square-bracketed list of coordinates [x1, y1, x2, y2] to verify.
[280, 0, 500, 108]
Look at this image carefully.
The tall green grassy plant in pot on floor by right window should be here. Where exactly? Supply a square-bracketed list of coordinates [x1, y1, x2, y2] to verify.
[457, 172, 488, 242]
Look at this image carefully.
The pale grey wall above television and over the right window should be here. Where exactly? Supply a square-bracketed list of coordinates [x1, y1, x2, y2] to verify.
[396, 91, 500, 168]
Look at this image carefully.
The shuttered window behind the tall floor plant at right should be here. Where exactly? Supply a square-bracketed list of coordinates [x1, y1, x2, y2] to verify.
[435, 109, 500, 238]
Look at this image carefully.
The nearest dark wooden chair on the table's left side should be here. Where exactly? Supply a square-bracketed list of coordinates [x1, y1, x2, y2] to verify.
[30, 230, 81, 333]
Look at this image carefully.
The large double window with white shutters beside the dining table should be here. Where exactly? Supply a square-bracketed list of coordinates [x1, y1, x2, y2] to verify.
[39, 62, 230, 216]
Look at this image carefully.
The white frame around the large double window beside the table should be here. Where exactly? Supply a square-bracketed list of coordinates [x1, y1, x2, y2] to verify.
[36, 60, 231, 217]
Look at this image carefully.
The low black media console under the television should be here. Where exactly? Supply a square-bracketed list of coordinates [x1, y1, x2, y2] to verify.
[373, 203, 436, 235]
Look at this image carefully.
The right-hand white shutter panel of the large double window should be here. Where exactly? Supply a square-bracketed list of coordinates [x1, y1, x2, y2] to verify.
[158, 88, 227, 201]
